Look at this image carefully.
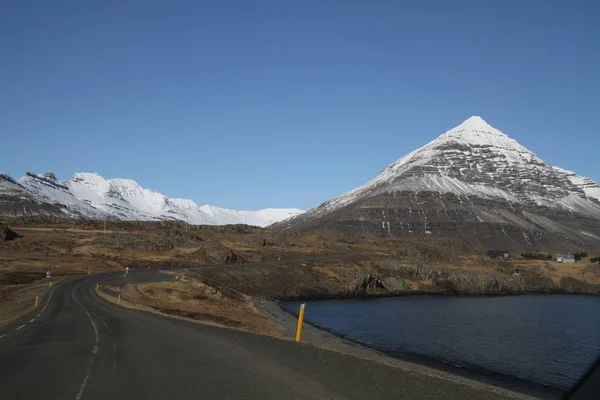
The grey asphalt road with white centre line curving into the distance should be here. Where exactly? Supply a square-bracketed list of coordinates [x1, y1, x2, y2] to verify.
[0, 270, 520, 400]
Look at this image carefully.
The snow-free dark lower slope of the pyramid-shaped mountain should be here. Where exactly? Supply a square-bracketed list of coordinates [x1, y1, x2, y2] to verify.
[276, 191, 600, 251]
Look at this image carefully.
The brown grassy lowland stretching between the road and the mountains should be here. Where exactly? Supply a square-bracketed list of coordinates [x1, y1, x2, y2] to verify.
[0, 221, 600, 333]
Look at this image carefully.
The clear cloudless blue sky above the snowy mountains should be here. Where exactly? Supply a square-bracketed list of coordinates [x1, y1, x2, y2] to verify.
[0, 0, 600, 209]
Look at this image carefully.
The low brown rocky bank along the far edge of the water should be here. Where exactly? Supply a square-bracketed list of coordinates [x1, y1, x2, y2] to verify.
[194, 255, 600, 300]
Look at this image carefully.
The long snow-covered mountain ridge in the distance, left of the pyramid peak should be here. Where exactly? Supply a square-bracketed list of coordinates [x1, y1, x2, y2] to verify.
[0, 172, 303, 226]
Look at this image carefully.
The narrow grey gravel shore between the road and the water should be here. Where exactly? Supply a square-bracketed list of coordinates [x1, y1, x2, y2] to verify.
[254, 293, 567, 399]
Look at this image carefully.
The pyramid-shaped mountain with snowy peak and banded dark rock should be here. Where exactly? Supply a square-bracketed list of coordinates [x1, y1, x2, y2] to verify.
[273, 117, 600, 250]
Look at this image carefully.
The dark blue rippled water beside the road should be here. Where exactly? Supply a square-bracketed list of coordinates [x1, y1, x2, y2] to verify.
[283, 295, 600, 389]
